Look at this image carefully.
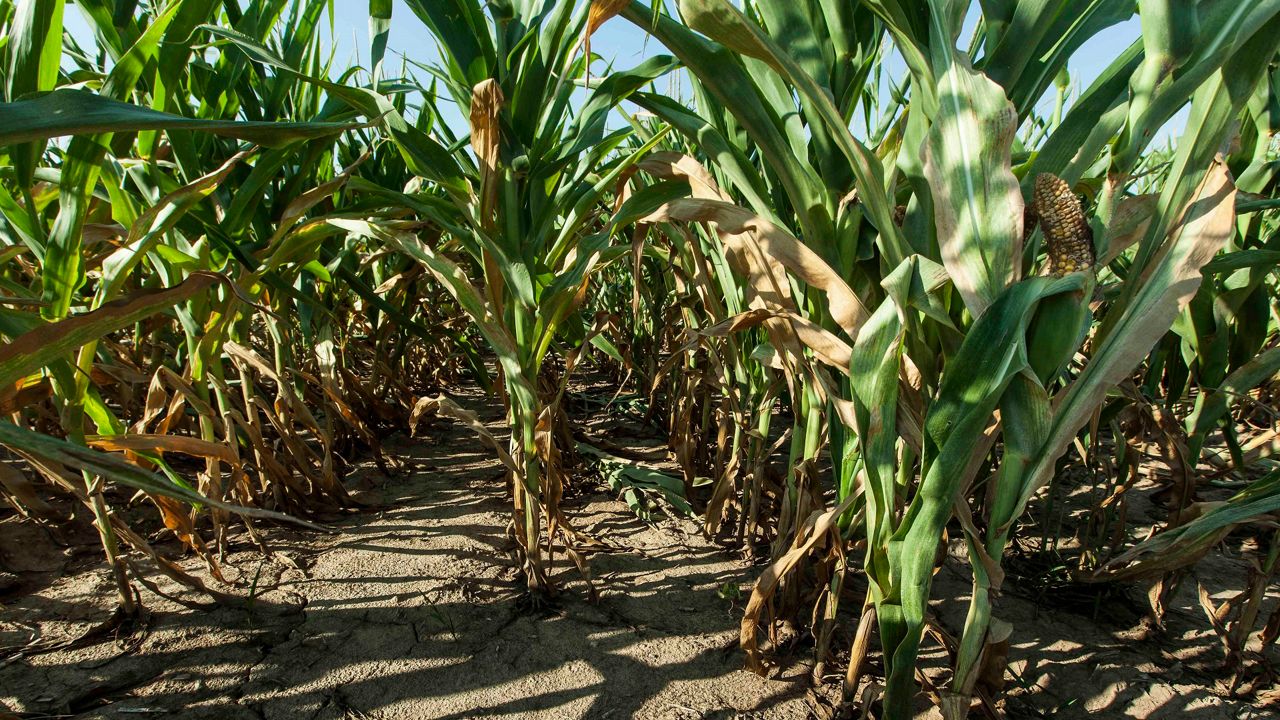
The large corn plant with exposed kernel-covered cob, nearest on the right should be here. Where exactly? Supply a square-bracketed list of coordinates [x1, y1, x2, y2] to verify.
[628, 0, 1275, 717]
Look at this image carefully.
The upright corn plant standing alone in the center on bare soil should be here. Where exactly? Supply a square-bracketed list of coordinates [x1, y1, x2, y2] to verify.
[335, 0, 673, 592]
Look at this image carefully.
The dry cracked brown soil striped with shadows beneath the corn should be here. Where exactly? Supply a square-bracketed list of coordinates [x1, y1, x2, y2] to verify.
[0, 386, 1266, 720]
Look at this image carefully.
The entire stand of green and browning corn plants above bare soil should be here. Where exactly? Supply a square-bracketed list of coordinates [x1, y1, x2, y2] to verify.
[0, 0, 1280, 720]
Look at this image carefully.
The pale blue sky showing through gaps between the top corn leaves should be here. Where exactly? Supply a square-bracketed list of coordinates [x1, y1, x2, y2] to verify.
[65, 0, 1187, 137]
